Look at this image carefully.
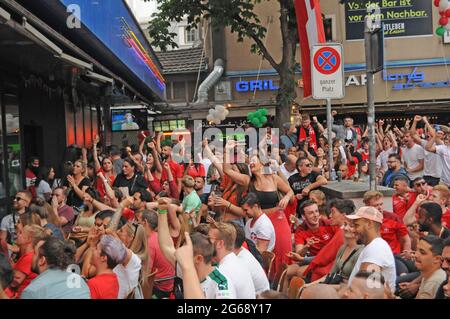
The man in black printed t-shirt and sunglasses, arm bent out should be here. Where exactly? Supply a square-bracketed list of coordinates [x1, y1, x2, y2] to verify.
[288, 158, 327, 216]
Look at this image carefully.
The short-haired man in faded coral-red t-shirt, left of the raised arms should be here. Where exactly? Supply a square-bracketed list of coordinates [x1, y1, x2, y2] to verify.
[141, 210, 175, 299]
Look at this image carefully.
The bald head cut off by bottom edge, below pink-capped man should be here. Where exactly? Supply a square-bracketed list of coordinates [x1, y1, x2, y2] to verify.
[342, 271, 385, 299]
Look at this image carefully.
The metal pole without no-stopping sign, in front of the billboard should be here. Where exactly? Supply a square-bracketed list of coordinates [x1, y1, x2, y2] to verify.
[364, 28, 377, 191]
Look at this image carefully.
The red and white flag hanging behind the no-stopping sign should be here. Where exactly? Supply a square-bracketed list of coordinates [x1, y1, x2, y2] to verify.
[295, 0, 325, 97]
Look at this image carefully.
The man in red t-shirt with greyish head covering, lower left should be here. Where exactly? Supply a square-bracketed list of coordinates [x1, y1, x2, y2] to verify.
[88, 235, 122, 299]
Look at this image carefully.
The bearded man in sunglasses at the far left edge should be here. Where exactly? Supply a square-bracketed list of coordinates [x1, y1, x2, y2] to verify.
[0, 191, 32, 244]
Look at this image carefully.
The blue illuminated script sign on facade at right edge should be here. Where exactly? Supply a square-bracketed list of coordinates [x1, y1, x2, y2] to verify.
[383, 68, 450, 90]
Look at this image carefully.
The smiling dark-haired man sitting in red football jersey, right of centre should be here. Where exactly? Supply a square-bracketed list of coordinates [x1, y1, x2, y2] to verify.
[284, 200, 339, 287]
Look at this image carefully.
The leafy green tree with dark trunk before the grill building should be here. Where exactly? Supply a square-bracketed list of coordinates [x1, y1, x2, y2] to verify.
[145, 0, 298, 127]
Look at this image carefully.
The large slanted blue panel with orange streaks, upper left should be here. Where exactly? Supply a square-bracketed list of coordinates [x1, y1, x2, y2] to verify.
[59, 0, 166, 99]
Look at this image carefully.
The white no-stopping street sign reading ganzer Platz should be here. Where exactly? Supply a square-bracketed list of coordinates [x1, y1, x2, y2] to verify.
[311, 43, 345, 100]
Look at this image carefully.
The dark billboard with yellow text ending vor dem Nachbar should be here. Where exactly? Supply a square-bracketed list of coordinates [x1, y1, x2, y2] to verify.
[345, 0, 433, 40]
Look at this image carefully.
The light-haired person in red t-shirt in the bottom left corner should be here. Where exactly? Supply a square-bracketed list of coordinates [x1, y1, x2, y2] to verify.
[6, 225, 44, 299]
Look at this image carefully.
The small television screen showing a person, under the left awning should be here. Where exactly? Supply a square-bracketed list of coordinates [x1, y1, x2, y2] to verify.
[111, 109, 148, 132]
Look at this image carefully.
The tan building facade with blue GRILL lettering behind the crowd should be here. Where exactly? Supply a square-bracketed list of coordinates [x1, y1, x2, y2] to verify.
[142, 0, 450, 131]
